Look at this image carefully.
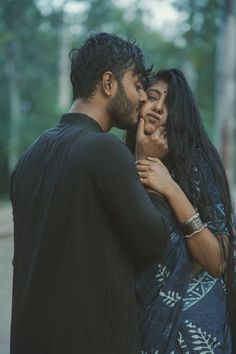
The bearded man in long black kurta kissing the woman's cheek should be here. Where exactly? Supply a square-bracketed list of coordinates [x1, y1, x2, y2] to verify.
[11, 33, 169, 354]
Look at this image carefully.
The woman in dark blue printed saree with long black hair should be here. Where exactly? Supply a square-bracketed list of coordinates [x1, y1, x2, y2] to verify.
[127, 69, 235, 354]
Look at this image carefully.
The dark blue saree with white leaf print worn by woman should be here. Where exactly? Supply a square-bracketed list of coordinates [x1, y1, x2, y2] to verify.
[136, 151, 233, 354]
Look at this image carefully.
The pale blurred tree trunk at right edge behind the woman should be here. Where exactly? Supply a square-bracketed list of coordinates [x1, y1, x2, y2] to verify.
[215, 0, 236, 194]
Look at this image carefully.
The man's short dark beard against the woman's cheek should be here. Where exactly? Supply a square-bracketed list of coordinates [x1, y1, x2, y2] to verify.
[107, 82, 141, 130]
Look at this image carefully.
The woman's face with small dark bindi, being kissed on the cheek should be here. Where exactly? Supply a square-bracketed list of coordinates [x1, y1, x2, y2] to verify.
[141, 80, 168, 134]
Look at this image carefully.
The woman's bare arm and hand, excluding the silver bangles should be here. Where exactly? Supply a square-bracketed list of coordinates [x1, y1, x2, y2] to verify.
[136, 158, 227, 277]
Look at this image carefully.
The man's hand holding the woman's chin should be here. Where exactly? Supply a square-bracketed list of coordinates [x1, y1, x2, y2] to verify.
[136, 118, 168, 160]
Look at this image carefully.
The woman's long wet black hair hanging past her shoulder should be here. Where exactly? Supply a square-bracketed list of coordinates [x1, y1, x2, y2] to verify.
[126, 69, 236, 338]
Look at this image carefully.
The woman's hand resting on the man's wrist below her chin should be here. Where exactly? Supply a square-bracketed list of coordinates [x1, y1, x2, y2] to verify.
[136, 157, 176, 196]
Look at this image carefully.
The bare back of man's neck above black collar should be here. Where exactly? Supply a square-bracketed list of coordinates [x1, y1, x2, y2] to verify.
[69, 99, 111, 132]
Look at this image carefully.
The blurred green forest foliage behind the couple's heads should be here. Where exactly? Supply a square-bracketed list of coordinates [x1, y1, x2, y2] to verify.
[0, 0, 224, 196]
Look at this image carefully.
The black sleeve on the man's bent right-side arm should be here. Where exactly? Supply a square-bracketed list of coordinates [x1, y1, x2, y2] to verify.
[96, 140, 170, 262]
